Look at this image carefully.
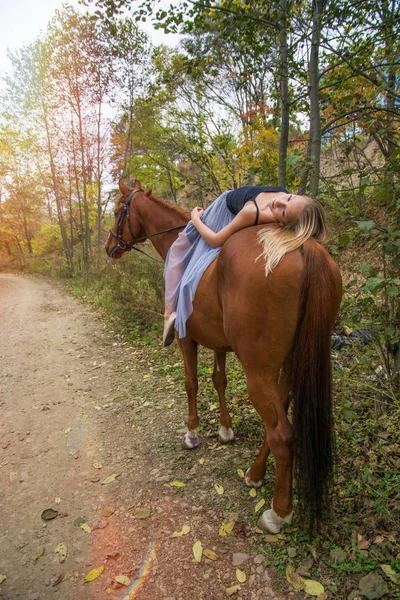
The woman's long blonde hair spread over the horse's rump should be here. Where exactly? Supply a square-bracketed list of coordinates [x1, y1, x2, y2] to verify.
[256, 196, 328, 276]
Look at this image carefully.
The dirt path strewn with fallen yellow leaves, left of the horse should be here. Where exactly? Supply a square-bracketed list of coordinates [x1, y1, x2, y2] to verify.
[0, 275, 292, 600]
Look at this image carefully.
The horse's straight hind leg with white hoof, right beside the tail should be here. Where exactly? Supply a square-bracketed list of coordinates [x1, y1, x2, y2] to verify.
[247, 372, 292, 533]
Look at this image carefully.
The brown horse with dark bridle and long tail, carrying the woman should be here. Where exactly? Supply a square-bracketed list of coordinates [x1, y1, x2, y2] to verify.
[106, 181, 342, 533]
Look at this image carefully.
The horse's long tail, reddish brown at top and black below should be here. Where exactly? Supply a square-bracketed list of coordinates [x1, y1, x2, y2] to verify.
[292, 241, 339, 530]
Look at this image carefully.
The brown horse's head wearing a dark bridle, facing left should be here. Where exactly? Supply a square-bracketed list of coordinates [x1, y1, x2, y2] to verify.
[105, 179, 146, 258]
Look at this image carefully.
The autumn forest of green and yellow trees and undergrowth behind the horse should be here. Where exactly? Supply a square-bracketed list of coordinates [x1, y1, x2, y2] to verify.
[0, 0, 400, 596]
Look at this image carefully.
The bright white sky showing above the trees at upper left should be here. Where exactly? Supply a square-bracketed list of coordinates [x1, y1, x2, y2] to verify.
[0, 0, 179, 77]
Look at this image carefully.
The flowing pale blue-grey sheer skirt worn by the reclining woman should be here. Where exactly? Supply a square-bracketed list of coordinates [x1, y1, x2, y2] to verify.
[164, 190, 235, 338]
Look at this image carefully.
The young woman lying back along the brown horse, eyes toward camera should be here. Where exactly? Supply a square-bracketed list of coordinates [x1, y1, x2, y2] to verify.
[163, 186, 327, 346]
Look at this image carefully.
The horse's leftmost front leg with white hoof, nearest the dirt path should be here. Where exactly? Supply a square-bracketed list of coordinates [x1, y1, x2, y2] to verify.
[178, 335, 200, 450]
